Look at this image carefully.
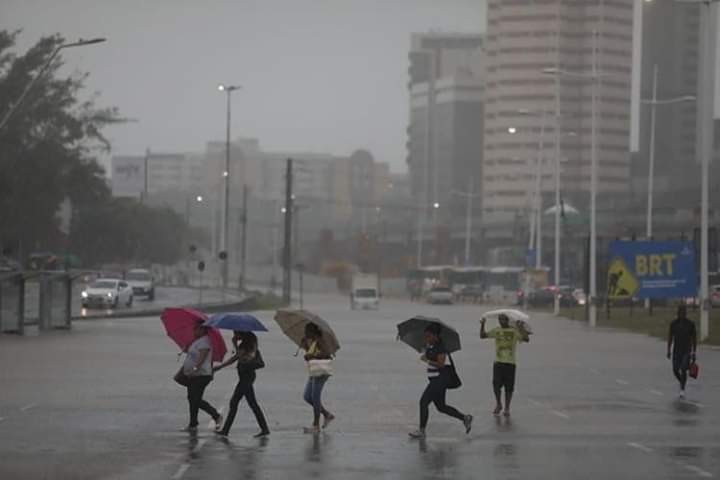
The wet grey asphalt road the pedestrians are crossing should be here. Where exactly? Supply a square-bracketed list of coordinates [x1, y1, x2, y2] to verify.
[0, 297, 720, 480]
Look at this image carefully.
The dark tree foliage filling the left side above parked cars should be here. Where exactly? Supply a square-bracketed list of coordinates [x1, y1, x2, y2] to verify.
[0, 30, 187, 264]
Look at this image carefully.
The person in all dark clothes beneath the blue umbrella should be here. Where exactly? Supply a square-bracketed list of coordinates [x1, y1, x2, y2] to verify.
[213, 331, 270, 438]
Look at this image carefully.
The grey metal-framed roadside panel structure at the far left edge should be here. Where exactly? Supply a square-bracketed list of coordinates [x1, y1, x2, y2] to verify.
[0, 272, 73, 335]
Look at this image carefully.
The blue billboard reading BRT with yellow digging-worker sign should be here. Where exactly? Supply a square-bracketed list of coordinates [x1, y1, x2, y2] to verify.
[607, 240, 698, 299]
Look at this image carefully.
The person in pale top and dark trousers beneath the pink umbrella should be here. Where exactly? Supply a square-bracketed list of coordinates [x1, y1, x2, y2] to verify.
[183, 323, 223, 433]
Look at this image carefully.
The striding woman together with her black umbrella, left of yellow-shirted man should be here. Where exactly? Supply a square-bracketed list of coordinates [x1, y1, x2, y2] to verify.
[398, 317, 473, 439]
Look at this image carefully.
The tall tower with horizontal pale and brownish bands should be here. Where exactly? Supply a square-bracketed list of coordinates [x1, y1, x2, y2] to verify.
[483, 0, 636, 251]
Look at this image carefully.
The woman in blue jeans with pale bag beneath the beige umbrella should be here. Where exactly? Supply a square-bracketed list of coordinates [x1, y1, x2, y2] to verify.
[301, 323, 335, 433]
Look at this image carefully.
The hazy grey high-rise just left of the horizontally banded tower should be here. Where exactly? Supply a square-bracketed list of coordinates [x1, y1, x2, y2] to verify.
[407, 33, 484, 263]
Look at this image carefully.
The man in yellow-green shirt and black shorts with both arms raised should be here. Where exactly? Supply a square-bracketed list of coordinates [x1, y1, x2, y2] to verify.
[480, 314, 530, 417]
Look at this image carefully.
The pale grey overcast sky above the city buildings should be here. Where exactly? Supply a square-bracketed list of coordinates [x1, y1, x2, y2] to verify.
[0, 0, 485, 171]
